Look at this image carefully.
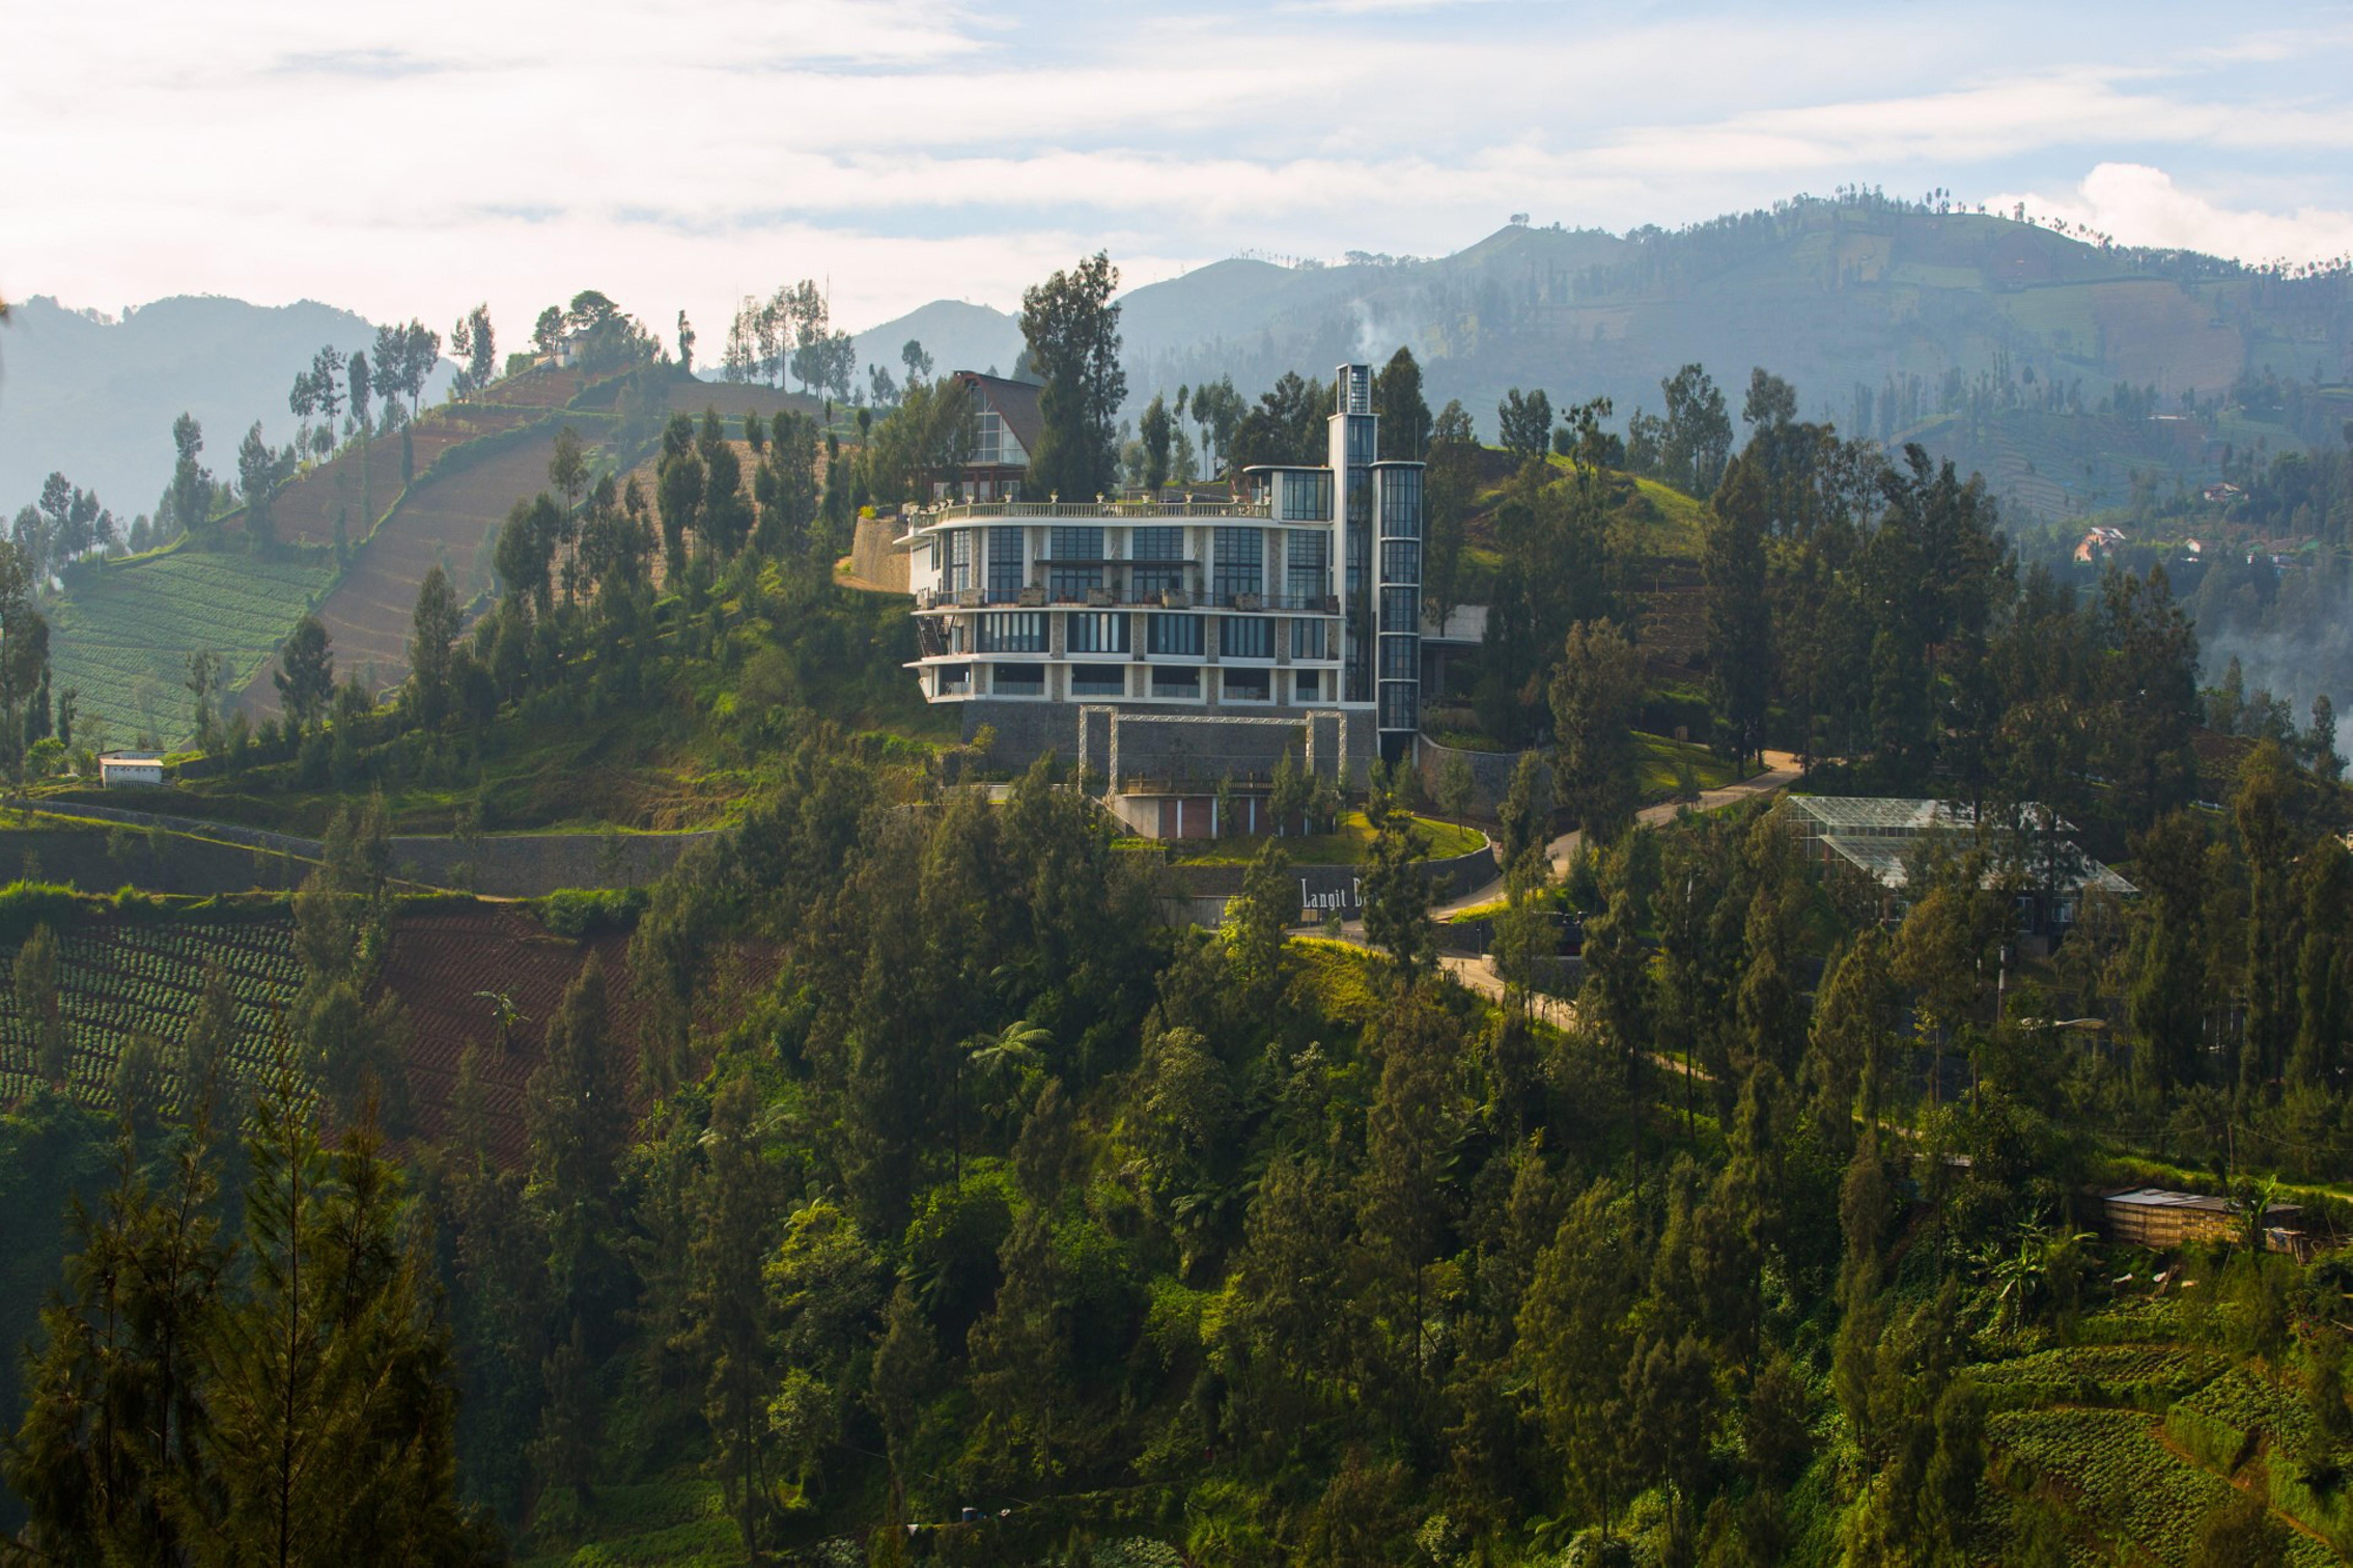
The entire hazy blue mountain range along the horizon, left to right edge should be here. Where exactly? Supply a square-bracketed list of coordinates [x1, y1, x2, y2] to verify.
[0, 198, 2353, 516]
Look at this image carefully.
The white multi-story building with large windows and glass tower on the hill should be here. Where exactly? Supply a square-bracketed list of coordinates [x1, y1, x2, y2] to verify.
[901, 365, 1421, 779]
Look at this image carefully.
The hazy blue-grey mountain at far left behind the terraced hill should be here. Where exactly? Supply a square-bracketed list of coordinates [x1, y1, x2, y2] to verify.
[0, 294, 447, 520]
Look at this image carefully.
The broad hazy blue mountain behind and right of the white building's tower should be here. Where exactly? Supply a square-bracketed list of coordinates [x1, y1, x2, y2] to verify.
[1092, 198, 2353, 516]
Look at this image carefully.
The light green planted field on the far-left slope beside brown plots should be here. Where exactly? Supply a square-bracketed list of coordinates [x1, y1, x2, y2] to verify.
[49, 546, 334, 746]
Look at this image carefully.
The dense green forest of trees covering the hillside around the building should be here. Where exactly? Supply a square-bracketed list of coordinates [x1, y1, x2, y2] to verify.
[0, 259, 2353, 1568]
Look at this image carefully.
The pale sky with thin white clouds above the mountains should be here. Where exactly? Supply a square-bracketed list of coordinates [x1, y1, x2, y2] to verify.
[0, 0, 2353, 358]
